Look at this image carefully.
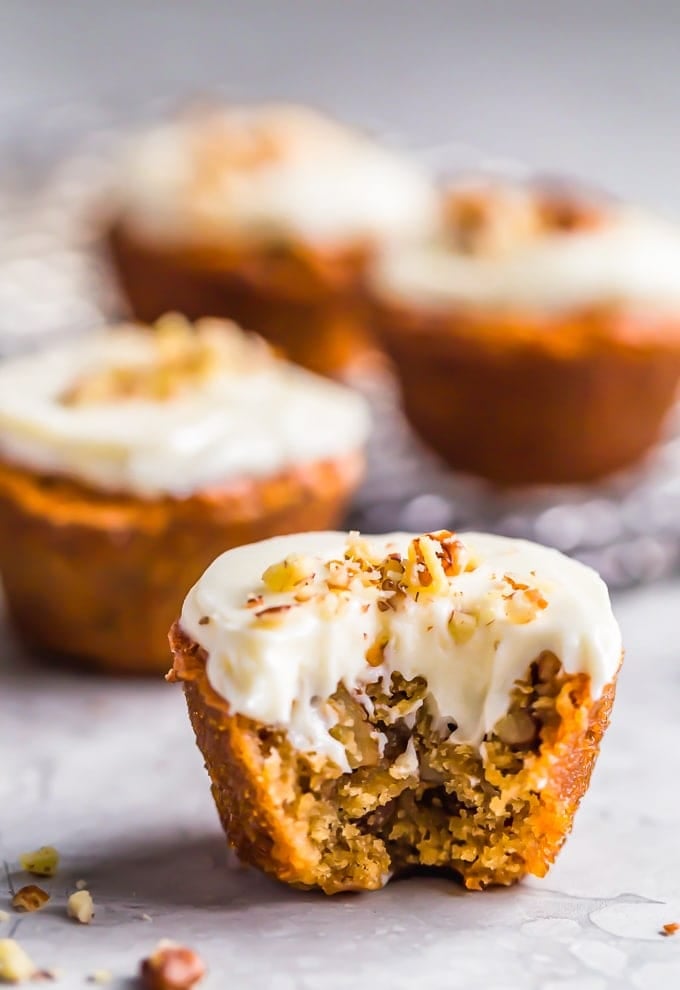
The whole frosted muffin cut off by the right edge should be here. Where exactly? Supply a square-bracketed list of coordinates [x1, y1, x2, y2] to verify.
[373, 184, 680, 484]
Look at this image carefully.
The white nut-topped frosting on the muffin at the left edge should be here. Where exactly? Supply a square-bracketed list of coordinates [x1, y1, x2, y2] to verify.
[0, 320, 369, 497]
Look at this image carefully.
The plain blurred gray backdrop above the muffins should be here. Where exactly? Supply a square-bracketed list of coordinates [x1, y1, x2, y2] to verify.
[0, 0, 680, 214]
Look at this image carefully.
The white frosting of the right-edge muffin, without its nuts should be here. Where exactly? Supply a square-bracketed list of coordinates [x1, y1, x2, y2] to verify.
[374, 206, 680, 311]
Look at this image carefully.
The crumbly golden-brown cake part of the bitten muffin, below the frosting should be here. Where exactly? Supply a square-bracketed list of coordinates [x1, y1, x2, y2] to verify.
[168, 624, 615, 894]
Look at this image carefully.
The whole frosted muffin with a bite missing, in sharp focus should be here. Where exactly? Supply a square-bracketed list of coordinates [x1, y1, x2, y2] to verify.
[168, 531, 621, 894]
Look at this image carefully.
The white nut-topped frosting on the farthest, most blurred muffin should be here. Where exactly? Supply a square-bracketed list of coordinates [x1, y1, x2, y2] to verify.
[119, 105, 439, 245]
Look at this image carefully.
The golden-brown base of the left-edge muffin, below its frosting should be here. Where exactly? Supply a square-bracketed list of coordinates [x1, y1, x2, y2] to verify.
[0, 454, 363, 674]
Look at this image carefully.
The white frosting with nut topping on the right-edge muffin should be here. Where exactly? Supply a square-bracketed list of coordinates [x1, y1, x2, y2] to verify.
[374, 187, 680, 310]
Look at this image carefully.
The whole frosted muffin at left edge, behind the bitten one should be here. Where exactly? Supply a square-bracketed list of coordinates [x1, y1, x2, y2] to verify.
[0, 317, 368, 673]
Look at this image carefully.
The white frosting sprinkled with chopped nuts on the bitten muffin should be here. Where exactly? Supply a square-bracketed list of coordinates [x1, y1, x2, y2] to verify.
[180, 532, 621, 770]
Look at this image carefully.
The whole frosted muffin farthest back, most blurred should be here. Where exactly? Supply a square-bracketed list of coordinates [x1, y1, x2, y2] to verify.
[108, 105, 440, 374]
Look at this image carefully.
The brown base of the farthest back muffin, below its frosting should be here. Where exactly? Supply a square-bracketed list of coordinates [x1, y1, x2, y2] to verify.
[108, 223, 377, 376]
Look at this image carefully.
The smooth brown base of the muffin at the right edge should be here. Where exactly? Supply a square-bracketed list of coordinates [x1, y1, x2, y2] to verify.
[376, 304, 680, 485]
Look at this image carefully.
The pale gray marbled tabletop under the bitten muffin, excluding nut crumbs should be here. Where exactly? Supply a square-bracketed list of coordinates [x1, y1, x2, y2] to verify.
[0, 583, 680, 990]
